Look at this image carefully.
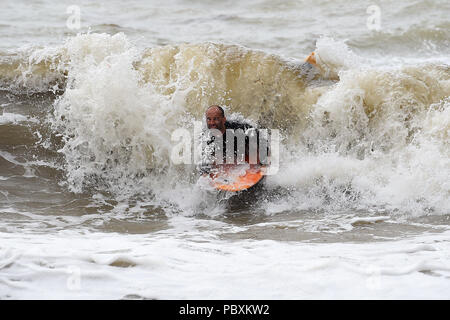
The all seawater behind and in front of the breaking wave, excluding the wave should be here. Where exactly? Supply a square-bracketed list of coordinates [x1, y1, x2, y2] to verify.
[0, 0, 450, 299]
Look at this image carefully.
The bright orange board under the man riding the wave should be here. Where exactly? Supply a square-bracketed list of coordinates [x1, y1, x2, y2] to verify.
[210, 165, 264, 192]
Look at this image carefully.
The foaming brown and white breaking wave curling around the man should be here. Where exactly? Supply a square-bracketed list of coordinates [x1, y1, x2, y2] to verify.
[0, 33, 450, 215]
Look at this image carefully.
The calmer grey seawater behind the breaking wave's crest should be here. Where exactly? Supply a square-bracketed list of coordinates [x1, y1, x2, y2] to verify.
[0, 0, 449, 59]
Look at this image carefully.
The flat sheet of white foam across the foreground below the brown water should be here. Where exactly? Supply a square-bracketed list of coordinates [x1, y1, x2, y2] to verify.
[0, 225, 450, 299]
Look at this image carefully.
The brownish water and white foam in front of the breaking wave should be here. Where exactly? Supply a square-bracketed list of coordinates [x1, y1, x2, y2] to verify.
[0, 92, 450, 299]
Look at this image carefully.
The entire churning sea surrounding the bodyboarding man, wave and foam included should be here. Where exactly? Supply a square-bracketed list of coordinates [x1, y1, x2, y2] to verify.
[0, 0, 450, 299]
